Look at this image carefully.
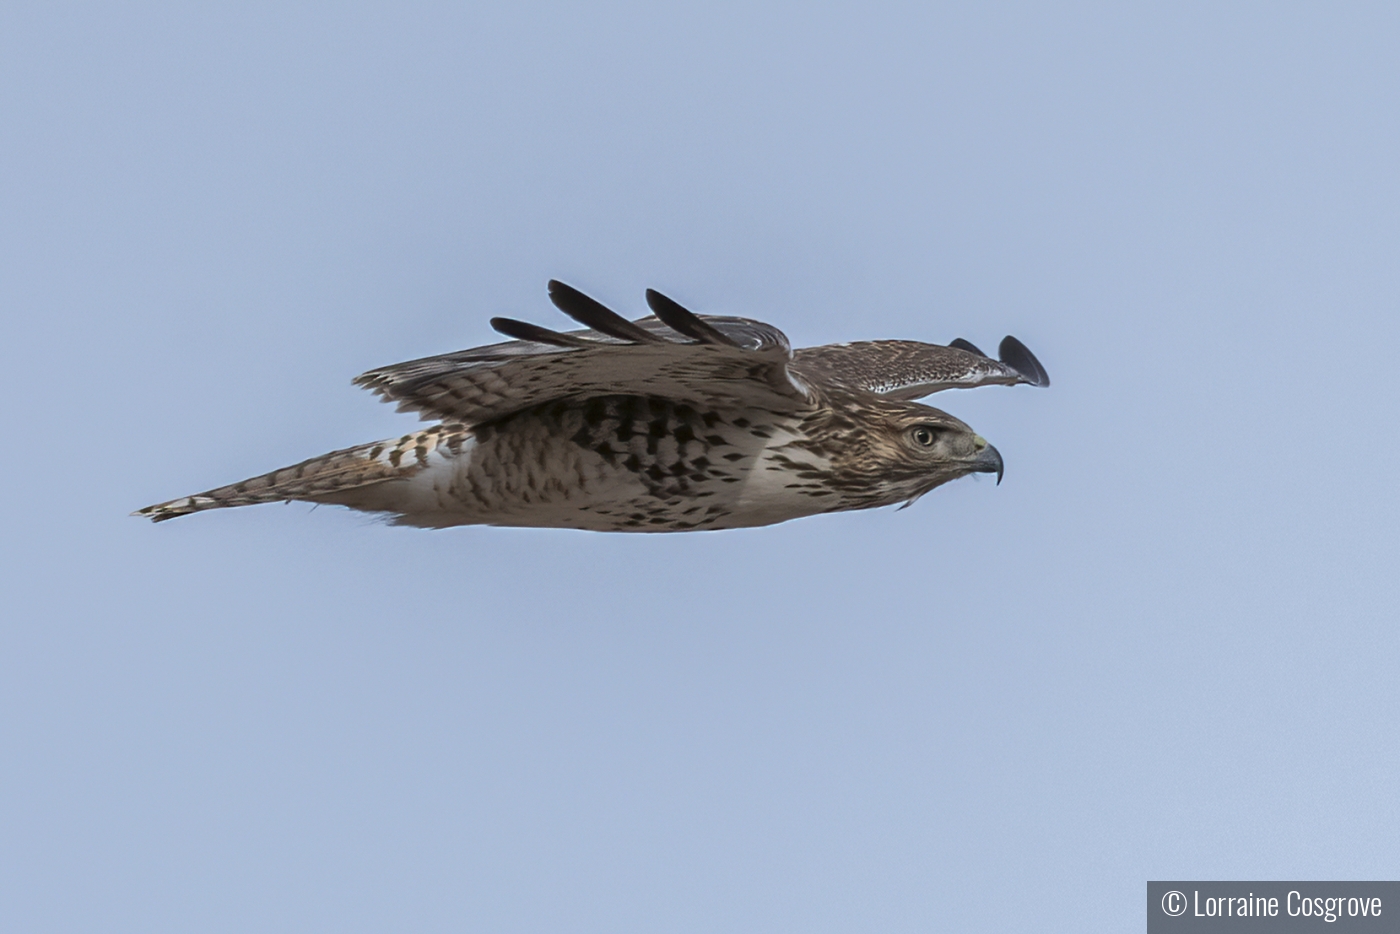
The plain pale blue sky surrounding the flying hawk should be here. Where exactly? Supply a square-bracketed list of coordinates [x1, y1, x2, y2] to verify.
[0, 1, 1400, 934]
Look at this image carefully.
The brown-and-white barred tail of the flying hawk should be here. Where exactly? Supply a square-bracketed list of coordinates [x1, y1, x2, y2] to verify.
[132, 424, 466, 522]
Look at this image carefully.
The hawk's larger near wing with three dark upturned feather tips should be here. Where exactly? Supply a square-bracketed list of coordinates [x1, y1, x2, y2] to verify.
[356, 280, 813, 424]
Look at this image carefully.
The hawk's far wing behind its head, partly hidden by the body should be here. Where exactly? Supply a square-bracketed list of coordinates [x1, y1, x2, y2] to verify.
[792, 336, 1050, 399]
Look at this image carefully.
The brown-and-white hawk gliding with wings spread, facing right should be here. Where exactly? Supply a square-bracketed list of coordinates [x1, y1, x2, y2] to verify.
[134, 281, 1050, 532]
